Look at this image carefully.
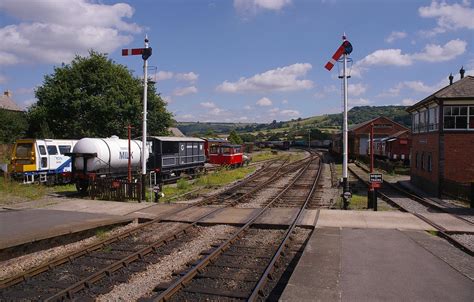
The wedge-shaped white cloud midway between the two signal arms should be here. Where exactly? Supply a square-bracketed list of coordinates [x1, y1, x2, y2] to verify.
[216, 63, 313, 93]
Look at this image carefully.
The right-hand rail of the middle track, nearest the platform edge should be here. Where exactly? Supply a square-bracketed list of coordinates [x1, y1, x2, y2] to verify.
[248, 158, 322, 301]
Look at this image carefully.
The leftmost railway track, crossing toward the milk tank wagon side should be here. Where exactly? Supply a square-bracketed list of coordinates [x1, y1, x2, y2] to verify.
[0, 152, 318, 301]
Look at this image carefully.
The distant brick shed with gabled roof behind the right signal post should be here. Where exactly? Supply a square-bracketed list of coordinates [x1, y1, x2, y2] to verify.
[331, 116, 410, 158]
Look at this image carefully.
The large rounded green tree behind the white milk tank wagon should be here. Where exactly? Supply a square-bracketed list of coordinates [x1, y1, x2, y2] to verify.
[28, 51, 172, 138]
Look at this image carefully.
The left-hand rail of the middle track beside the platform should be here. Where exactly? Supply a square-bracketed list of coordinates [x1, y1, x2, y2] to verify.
[152, 153, 320, 301]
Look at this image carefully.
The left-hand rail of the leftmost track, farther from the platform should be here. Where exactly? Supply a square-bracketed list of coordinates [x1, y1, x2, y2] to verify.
[0, 156, 283, 289]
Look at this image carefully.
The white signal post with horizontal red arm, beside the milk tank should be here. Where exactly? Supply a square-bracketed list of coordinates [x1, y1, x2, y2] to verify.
[122, 36, 152, 200]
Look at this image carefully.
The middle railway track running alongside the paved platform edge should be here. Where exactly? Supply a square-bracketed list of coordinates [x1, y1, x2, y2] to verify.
[151, 158, 321, 301]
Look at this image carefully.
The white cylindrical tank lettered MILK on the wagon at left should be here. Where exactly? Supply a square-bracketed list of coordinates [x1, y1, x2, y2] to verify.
[72, 136, 148, 174]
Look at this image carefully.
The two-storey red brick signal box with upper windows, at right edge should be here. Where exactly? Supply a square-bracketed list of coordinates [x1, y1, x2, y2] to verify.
[407, 69, 474, 198]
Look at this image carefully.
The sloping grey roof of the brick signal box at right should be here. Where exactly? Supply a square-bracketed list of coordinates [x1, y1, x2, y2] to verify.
[407, 75, 474, 112]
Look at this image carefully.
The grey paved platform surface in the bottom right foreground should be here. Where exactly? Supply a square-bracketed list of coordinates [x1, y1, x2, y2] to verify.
[280, 228, 474, 302]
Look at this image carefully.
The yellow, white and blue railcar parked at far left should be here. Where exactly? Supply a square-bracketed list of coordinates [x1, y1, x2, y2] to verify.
[9, 139, 77, 184]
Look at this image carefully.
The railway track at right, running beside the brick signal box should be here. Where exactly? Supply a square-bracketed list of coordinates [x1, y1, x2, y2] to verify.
[349, 162, 474, 256]
